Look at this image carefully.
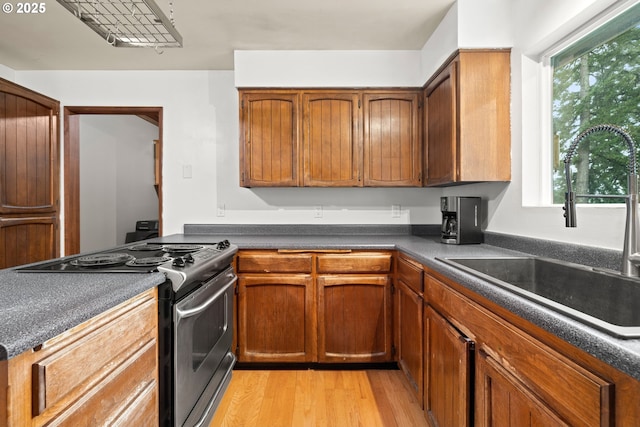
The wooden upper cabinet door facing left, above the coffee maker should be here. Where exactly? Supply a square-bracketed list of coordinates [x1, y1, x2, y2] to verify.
[425, 61, 458, 185]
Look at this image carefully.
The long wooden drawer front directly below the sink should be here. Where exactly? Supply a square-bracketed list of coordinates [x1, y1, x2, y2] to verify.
[426, 275, 614, 427]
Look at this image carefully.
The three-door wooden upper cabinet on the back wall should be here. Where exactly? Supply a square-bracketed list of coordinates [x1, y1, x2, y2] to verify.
[239, 89, 422, 187]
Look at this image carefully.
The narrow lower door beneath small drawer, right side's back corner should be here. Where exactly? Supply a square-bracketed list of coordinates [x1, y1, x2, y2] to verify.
[395, 281, 424, 404]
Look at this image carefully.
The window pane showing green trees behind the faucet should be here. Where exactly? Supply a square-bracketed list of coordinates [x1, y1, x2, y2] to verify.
[551, 4, 640, 203]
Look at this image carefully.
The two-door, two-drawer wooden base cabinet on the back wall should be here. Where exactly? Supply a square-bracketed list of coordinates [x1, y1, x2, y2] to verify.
[237, 250, 392, 363]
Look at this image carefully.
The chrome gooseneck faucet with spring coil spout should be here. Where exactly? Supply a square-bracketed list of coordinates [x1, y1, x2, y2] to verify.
[563, 124, 640, 277]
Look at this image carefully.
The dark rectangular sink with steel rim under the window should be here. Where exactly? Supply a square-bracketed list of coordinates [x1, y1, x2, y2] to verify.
[438, 257, 640, 338]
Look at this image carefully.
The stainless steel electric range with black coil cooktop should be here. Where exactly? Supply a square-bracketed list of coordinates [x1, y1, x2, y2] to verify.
[17, 240, 238, 427]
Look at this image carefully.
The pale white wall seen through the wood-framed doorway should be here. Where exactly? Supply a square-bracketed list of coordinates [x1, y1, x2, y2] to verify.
[80, 115, 159, 252]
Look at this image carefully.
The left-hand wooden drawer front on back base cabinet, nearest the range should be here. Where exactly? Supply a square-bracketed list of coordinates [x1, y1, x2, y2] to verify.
[238, 252, 313, 273]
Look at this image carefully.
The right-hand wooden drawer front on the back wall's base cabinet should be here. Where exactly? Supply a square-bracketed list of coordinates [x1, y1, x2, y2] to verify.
[317, 252, 391, 273]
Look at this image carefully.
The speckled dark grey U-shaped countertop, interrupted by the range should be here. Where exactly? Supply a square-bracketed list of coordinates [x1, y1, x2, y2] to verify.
[0, 225, 640, 380]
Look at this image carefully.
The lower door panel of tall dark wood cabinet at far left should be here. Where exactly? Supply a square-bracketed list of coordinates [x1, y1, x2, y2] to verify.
[0, 216, 59, 269]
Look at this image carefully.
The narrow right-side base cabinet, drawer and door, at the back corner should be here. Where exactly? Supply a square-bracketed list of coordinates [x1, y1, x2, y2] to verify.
[394, 254, 424, 404]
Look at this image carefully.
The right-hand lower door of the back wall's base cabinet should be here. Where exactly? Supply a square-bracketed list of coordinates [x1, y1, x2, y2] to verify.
[316, 275, 392, 362]
